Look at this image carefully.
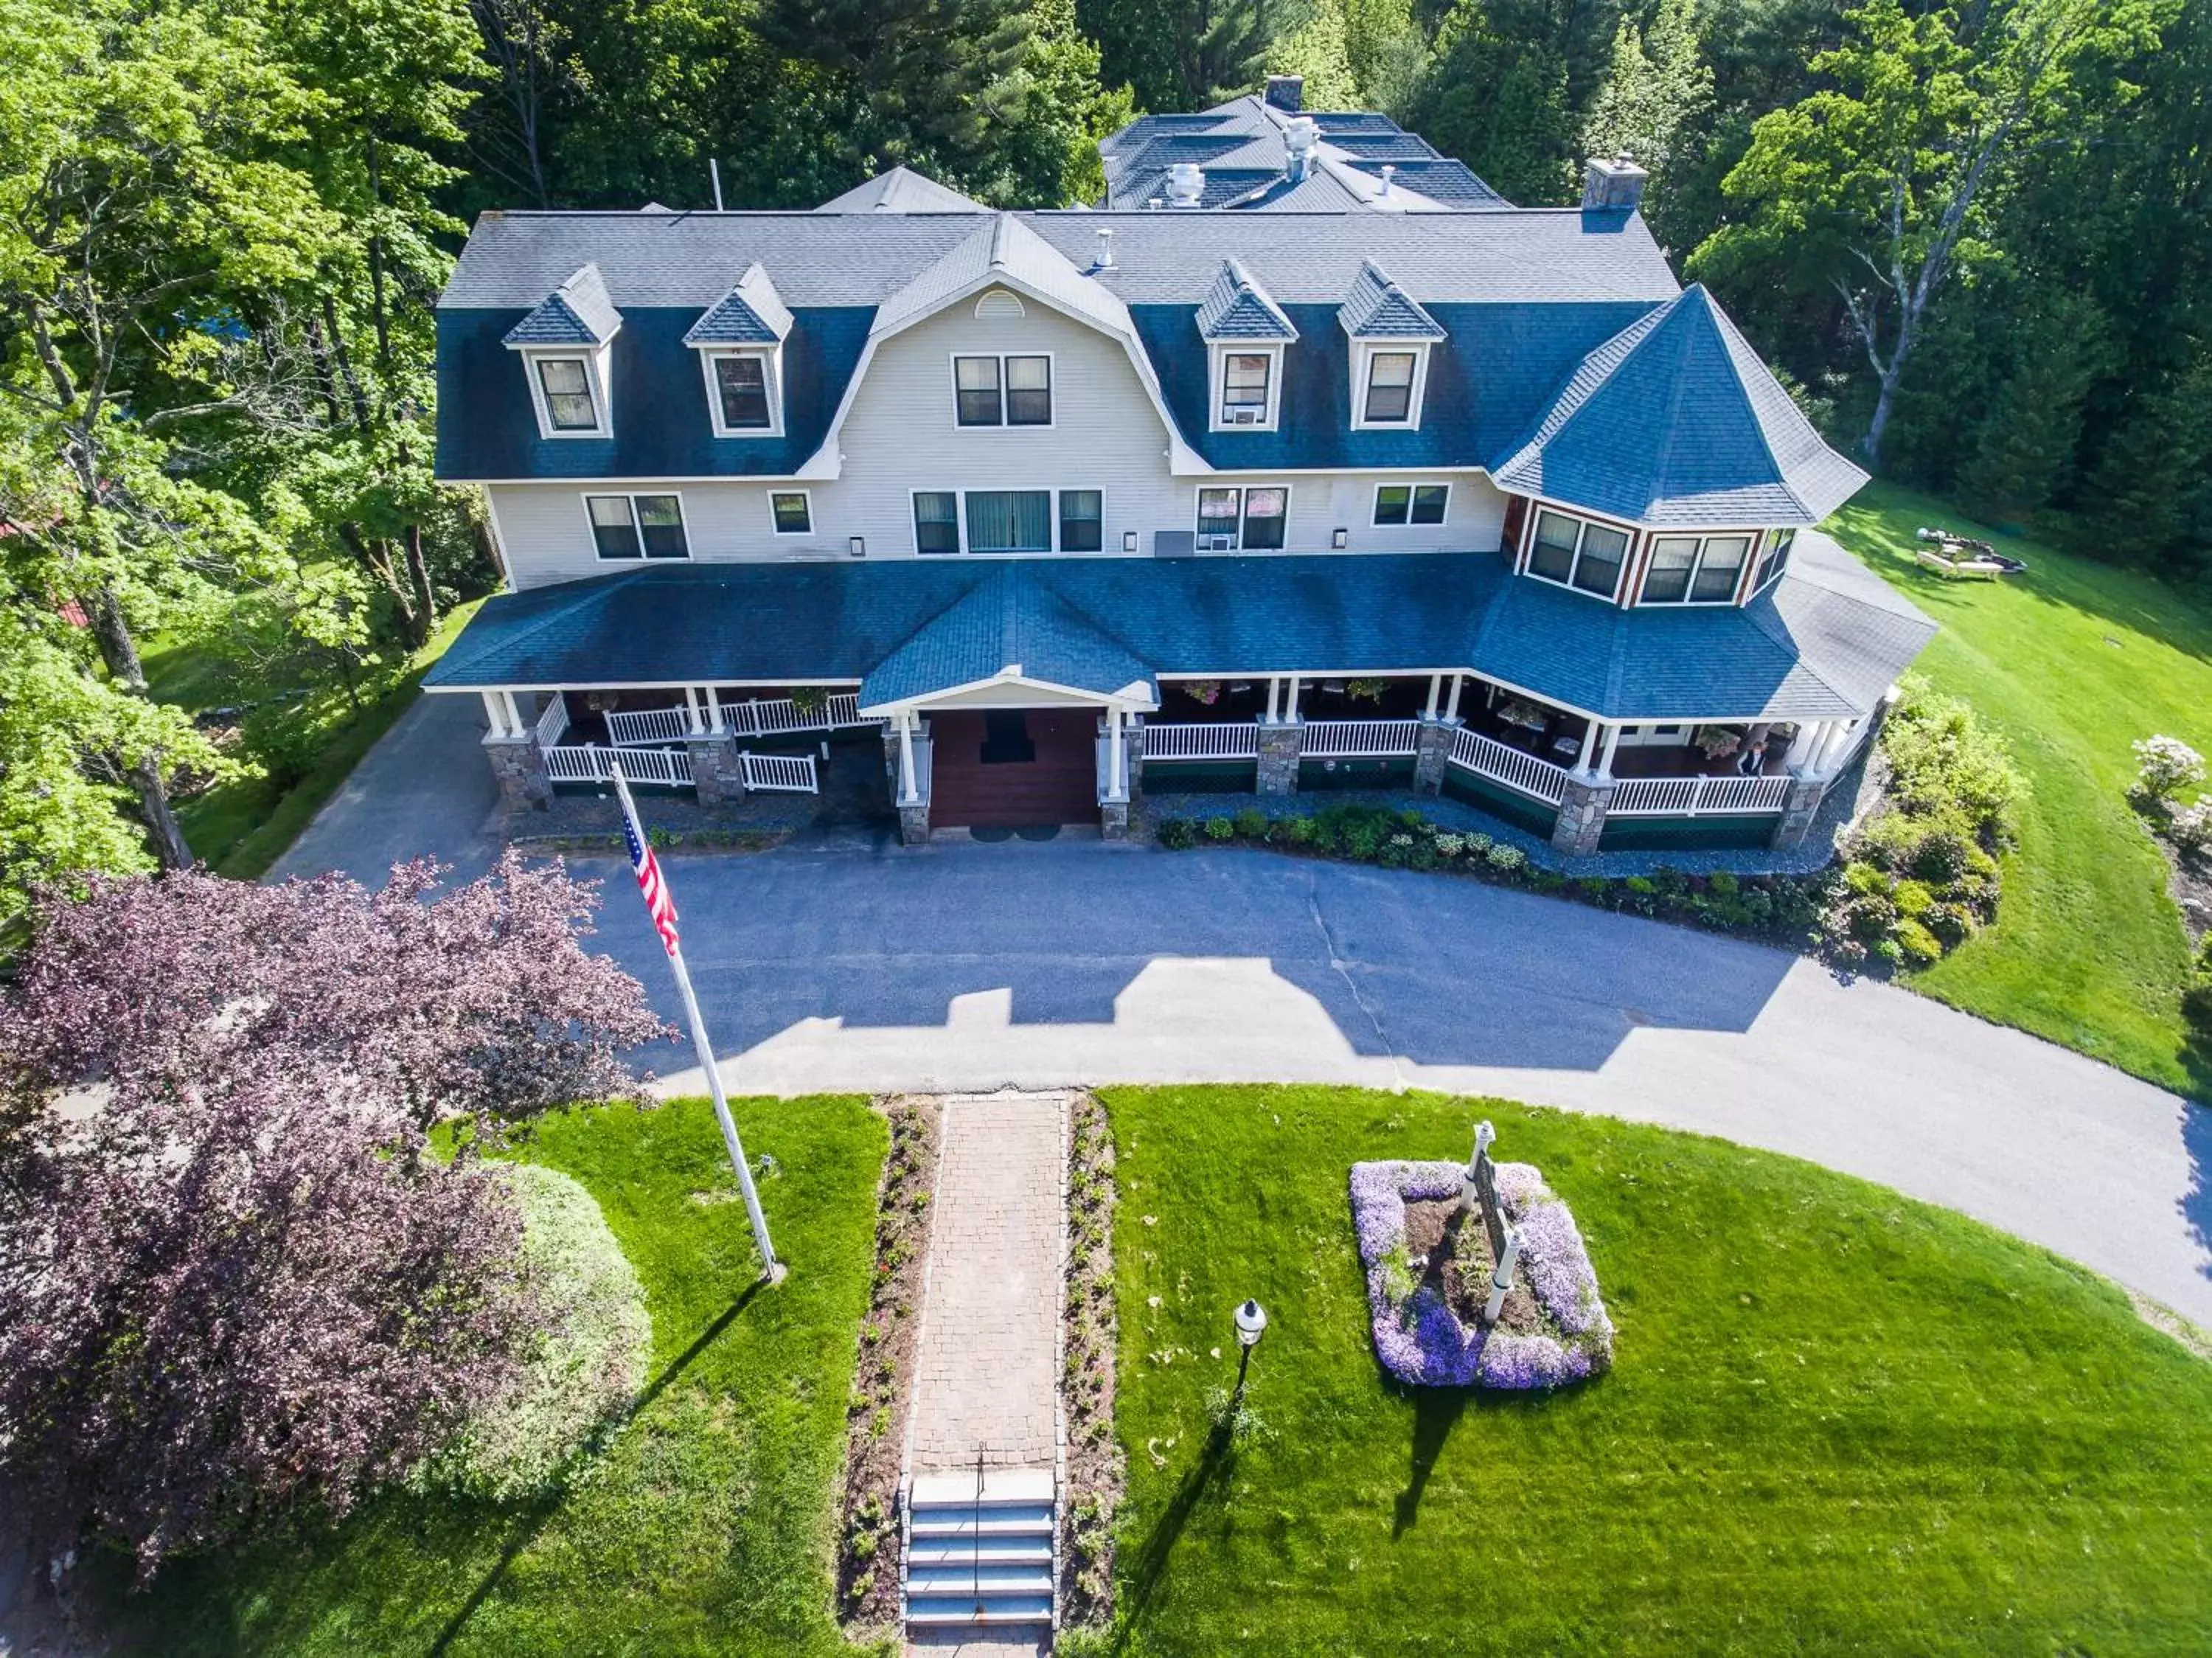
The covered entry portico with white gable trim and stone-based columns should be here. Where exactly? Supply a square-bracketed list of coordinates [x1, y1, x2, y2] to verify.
[863, 662, 1159, 846]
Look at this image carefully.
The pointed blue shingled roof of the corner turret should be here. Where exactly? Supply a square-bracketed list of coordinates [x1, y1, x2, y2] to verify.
[1493, 285, 1865, 524]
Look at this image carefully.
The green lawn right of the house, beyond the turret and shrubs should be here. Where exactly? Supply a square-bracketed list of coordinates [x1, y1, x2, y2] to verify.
[1829, 487, 2212, 1098]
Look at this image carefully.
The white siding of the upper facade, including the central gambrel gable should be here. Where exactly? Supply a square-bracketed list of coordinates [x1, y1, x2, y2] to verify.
[491, 283, 1504, 586]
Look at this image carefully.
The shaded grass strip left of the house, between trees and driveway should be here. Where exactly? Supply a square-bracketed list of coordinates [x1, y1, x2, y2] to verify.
[146, 600, 482, 881]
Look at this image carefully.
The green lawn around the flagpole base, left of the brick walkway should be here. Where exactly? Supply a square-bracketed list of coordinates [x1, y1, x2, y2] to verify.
[126, 1098, 887, 1658]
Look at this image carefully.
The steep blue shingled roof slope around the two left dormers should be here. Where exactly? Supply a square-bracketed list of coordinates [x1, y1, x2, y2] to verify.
[438, 305, 876, 480]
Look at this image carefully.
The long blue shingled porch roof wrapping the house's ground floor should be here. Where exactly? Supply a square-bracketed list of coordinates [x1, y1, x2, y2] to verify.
[427, 535, 1933, 719]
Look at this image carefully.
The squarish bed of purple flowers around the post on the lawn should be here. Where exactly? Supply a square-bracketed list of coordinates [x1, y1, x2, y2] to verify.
[1352, 1162, 1613, 1388]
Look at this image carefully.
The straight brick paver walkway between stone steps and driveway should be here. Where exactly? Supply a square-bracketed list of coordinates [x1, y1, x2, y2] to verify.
[909, 1094, 1068, 1472]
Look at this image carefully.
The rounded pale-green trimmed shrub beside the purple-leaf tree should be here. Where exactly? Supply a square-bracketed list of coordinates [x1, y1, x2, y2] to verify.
[416, 1162, 653, 1503]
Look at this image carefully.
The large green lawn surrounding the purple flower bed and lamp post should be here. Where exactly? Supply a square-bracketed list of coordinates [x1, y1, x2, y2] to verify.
[1104, 1087, 2212, 1658]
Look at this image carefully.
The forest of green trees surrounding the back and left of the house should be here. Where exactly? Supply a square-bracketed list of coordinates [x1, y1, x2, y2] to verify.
[0, 0, 2212, 912]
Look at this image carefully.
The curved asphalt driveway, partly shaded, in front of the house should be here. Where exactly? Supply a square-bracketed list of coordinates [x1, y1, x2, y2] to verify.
[281, 697, 2212, 1324]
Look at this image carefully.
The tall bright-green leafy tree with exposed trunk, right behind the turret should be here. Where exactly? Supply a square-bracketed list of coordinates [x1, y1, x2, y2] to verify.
[1690, 0, 2157, 462]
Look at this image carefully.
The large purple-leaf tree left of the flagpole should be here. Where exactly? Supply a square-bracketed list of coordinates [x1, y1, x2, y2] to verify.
[0, 859, 668, 1578]
